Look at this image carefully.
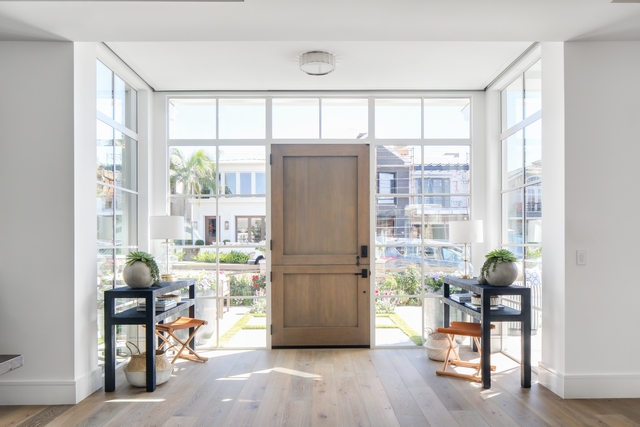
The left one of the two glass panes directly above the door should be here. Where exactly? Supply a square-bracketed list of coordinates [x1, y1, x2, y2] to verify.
[272, 98, 320, 139]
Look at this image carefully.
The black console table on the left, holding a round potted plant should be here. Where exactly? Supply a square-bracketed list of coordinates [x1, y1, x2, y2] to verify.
[104, 279, 196, 392]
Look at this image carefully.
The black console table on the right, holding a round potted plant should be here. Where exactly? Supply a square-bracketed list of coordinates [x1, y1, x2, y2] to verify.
[442, 276, 531, 388]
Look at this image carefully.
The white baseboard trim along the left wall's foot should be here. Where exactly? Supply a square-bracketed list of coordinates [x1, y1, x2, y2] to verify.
[0, 368, 102, 405]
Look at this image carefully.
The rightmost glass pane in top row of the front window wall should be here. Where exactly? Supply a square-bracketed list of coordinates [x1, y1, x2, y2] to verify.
[424, 98, 471, 138]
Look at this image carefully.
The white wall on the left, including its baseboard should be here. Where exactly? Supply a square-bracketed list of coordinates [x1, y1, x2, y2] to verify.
[0, 42, 99, 404]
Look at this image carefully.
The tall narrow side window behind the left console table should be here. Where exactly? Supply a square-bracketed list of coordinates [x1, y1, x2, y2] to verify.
[96, 61, 138, 372]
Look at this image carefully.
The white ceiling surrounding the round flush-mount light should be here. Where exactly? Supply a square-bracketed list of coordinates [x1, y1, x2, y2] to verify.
[0, 0, 640, 91]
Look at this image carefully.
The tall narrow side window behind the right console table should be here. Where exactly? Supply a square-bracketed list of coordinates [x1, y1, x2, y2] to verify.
[501, 60, 542, 366]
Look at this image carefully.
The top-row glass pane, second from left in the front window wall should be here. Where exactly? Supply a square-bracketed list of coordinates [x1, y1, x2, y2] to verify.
[218, 99, 266, 139]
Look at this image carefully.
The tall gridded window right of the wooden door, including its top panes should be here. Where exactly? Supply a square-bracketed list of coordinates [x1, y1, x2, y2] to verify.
[374, 97, 471, 346]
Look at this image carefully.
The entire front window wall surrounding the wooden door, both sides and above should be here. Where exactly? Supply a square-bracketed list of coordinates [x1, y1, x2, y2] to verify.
[167, 94, 471, 348]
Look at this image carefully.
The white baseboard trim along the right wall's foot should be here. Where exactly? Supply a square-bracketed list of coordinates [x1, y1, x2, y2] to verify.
[538, 362, 640, 399]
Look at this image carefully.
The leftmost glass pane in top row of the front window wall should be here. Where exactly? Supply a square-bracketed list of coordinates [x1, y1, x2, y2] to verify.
[169, 99, 216, 139]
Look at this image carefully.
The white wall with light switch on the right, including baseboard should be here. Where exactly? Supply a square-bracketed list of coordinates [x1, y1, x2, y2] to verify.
[540, 42, 640, 398]
